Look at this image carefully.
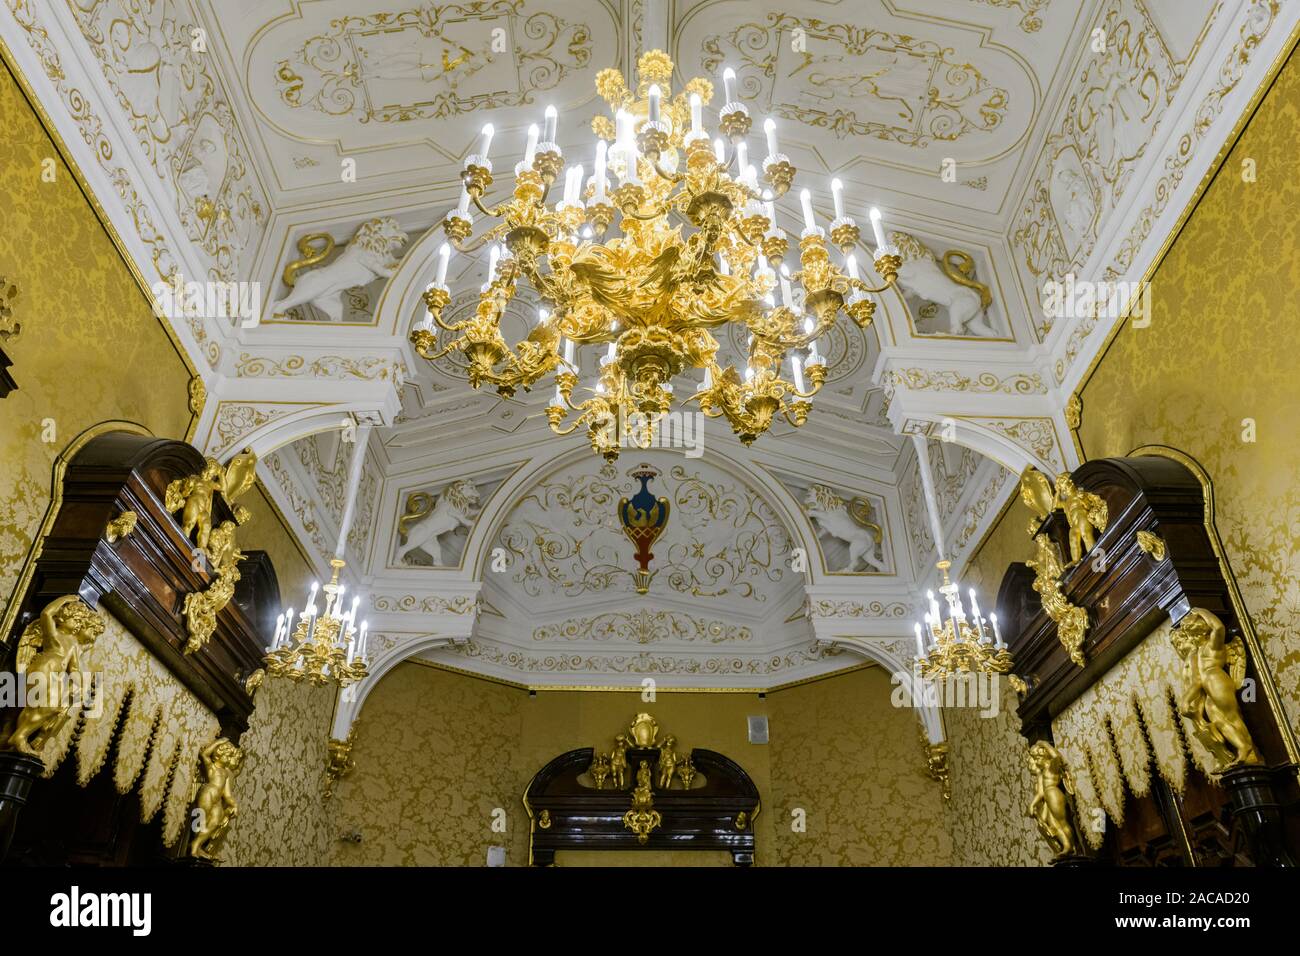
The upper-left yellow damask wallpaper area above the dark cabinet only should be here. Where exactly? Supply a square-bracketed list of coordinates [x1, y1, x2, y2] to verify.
[0, 59, 190, 629]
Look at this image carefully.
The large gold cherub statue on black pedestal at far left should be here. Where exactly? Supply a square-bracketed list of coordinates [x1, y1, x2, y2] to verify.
[4, 594, 104, 757]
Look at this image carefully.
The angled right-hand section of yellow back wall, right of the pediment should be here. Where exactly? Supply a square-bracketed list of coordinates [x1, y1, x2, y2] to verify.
[770, 667, 953, 866]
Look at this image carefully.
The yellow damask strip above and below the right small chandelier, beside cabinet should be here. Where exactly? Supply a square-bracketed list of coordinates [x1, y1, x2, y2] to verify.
[944, 496, 1050, 866]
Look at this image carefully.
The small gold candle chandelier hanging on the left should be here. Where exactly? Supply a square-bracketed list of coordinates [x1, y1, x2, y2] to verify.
[264, 558, 368, 687]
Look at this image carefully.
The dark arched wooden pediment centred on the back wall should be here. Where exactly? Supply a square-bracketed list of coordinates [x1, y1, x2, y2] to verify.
[524, 747, 759, 866]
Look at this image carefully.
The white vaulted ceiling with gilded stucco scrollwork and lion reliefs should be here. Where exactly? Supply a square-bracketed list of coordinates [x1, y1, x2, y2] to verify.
[0, 0, 1300, 702]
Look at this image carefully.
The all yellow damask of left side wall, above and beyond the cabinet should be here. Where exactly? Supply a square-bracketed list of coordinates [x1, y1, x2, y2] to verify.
[0, 54, 333, 865]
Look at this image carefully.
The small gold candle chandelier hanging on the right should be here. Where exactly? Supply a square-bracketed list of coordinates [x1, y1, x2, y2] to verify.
[915, 561, 1028, 693]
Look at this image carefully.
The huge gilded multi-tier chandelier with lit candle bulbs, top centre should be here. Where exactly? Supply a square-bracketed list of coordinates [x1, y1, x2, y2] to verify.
[411, 51, 901, 460]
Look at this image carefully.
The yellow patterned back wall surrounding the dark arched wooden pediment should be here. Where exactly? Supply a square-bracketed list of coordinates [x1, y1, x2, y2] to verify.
[333, 663, 950, 866]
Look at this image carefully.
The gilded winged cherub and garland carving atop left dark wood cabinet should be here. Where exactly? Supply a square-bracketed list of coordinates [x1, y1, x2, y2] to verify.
[164, 449, 257, 654]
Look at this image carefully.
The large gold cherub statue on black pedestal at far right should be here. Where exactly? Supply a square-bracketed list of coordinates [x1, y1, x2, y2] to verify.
[1169, 607, 1264, 774]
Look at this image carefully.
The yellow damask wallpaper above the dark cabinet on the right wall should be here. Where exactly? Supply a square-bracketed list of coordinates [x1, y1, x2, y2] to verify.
[1080, 42, 1300, 749]
